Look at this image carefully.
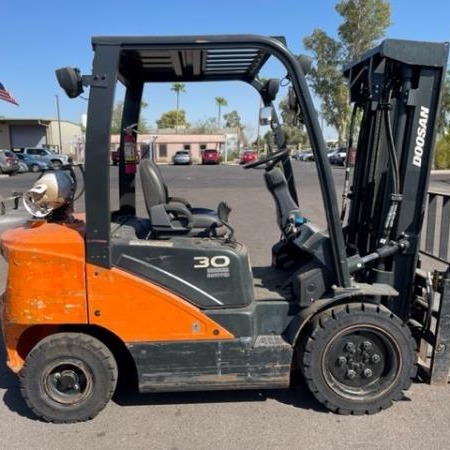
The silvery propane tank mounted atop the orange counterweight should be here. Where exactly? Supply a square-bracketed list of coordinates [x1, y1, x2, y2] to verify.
[23, 170, 76, 219]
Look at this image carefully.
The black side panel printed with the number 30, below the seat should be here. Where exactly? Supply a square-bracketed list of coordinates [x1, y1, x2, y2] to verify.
[111, 237, 254, 309]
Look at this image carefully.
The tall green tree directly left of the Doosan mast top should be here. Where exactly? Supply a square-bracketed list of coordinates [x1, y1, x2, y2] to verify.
[304, 0, 391, 145]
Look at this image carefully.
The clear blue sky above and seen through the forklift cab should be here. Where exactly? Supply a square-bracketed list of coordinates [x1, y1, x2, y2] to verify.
[0, 0, 450, 140]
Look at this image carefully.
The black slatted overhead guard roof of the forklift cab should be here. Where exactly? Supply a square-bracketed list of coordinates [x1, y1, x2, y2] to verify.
[92, 35, 285, 82]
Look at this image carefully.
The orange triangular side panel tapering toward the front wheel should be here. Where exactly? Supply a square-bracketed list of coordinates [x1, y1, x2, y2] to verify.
[86, 264, 233, 343]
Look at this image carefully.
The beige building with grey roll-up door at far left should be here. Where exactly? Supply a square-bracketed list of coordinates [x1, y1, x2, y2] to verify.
[0, 117, 82, 155]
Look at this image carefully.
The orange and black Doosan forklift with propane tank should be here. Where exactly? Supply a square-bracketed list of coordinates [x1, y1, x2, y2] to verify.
[1, 35, 450, 423]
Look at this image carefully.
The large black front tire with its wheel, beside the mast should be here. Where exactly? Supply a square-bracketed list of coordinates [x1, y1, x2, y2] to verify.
[300, 303, 417, 415]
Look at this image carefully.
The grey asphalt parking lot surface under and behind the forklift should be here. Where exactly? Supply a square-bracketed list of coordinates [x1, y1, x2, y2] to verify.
[0, 161, 450, 450]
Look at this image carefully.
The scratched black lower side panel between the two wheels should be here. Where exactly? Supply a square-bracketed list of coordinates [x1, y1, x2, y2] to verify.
[128, 335, 293, 392]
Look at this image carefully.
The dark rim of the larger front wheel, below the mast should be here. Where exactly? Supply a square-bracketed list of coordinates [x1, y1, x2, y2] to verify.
[322, 325, 401, 400]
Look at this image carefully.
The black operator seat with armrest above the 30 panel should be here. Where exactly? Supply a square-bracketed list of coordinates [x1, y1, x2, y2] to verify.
[139, 159, 227, 237]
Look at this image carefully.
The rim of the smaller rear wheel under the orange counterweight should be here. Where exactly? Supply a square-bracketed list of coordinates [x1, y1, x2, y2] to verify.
[42, 359, 92, 405]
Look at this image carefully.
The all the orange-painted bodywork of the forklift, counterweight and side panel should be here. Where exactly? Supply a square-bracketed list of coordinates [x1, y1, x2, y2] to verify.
[0, 220, 234, 372]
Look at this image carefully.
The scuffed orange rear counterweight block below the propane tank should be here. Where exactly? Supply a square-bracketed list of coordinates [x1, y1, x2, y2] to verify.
[2, 222, 87, 327]
